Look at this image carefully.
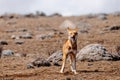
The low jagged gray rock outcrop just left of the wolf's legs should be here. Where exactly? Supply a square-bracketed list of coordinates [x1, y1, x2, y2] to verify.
[27, 51, 62, 69]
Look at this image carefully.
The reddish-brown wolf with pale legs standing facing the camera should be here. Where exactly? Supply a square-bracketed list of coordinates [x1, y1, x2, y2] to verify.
[60, 28, 77, 74]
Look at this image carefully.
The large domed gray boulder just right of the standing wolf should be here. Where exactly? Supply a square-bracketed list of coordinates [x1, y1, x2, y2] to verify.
[76, 44, 113, 61]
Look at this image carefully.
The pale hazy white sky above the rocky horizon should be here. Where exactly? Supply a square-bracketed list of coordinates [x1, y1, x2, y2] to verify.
[0, 0, 120, 16]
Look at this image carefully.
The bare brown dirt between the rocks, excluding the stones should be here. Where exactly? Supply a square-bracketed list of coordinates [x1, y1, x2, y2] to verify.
[0, 15, 120, 80]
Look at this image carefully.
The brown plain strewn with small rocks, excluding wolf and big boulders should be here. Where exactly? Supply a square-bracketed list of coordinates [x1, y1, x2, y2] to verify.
[0, 13, 120, 80]
